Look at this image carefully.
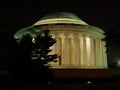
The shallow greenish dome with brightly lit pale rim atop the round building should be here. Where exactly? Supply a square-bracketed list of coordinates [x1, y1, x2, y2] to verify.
[34, 12, 88, 26]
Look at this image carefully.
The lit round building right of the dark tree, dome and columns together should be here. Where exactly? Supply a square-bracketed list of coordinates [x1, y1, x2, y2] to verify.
[34, 12, 107, 68]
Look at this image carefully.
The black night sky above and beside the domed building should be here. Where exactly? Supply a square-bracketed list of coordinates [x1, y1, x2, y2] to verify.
[0, 0, 120, 66]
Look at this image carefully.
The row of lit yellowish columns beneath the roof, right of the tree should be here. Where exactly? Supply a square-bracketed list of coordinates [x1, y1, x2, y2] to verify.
[50, 32, 107, 68]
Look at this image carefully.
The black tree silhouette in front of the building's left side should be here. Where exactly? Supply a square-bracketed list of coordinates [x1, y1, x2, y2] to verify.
[18, 30, 58, 82]
